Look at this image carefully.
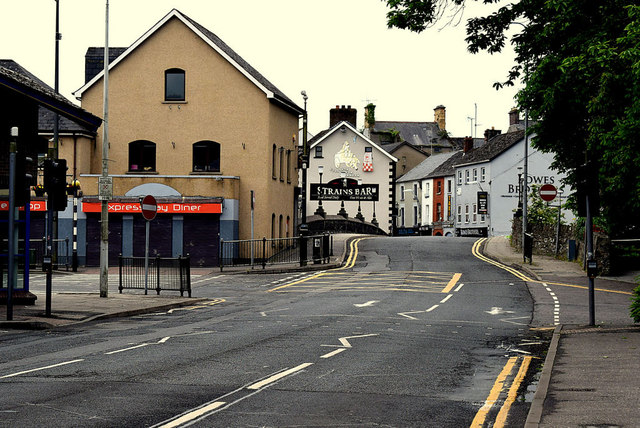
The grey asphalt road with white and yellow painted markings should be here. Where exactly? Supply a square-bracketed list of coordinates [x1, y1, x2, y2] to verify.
[0, 237, 543, 427]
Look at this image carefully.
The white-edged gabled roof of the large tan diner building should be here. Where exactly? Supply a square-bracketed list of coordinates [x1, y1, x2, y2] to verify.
[74, 9, 304, 114]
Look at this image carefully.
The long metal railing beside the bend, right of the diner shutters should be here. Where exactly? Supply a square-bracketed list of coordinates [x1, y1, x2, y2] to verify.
[220, 234, 333, 271]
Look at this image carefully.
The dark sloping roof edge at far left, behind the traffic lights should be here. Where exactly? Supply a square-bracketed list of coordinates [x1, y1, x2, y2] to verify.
[0, 60, 102, 130]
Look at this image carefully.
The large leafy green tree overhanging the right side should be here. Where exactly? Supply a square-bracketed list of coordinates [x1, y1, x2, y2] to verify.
[385, 0, 640, 236]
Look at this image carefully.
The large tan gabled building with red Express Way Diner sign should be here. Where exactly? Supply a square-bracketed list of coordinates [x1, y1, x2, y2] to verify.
[71, 9, 303, 265]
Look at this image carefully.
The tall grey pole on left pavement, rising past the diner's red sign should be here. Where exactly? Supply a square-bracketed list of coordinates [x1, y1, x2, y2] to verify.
[98, 0, 109, 297]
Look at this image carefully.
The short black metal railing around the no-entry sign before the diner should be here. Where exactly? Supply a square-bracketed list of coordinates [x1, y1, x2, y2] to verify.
[118, 255, 191, 297]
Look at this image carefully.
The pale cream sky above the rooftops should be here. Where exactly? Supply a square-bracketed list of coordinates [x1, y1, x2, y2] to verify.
[0, 0, 518, 137]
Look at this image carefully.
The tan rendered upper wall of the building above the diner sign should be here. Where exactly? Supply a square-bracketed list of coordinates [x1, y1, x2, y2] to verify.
[82, 17, 298, 239]
